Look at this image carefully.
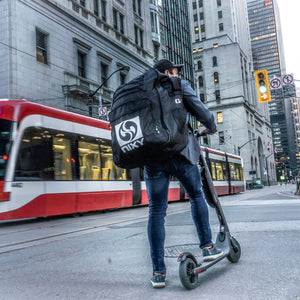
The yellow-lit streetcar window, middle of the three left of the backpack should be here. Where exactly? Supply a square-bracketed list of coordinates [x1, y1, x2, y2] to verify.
[78, 141, 101, 180]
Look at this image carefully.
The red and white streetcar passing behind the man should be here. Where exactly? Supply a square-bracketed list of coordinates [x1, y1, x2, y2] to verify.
[0, 100, 245, 220]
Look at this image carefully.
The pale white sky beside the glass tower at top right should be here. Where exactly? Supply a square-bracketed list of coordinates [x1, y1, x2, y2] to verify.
[277, 0, 300, 85]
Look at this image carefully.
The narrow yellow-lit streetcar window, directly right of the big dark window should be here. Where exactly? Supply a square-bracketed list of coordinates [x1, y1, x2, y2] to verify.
[53, 133, 73, 180]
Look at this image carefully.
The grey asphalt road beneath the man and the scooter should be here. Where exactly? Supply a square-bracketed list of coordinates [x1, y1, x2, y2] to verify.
[0, 185, 300, 300]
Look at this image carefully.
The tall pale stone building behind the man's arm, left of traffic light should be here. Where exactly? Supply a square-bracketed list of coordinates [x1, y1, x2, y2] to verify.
[189, 0, 276, 184]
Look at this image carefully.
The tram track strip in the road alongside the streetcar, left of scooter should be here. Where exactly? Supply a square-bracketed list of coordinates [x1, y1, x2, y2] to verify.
[0, 203, 189, 254]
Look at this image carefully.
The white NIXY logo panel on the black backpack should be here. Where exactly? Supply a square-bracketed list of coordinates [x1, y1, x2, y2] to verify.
[116, 117, 144, 153]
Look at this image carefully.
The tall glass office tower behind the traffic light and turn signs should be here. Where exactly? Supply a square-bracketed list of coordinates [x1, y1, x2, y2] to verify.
[247, 0, 297, 179]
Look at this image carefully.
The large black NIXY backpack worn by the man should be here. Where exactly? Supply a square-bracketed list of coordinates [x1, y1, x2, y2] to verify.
[109, 69, 188, 169]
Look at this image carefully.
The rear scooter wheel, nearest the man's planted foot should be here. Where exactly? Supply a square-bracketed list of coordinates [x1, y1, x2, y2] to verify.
[179, 258, 198, 290]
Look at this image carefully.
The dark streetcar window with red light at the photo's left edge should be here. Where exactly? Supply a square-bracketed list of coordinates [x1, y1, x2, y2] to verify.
[0, 119, 12, 180]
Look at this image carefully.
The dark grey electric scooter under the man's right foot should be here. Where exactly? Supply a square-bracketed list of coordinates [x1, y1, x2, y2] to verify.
[171, 134, 241, 290]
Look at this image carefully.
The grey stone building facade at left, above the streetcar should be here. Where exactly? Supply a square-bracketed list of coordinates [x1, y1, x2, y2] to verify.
[0, 0, 163, 117]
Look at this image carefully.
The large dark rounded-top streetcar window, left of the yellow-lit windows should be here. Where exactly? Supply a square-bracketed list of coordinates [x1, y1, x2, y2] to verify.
[15, 127, 54, 181]
